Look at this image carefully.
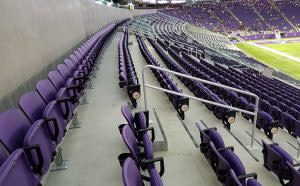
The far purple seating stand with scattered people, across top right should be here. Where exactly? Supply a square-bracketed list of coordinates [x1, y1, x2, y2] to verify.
[160, 0, 299, 34]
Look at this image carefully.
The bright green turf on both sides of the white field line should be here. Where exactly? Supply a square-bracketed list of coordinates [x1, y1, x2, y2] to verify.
[237, 42, 300, 80]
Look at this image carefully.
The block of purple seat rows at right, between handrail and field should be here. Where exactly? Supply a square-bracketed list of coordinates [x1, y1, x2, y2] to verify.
[152, 35, 300, 138]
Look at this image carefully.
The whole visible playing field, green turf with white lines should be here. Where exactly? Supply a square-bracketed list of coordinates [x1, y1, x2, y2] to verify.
[237, 39, 300, 80]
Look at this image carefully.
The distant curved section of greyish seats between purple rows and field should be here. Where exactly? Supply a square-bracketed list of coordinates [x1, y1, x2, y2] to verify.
[141, 14, 267, 73]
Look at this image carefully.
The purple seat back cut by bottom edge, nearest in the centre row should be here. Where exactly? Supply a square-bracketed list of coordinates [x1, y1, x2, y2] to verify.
[122, 157, 143, 186]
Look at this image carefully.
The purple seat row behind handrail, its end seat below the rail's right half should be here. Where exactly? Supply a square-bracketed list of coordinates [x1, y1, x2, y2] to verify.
[150, 40, 235, 128]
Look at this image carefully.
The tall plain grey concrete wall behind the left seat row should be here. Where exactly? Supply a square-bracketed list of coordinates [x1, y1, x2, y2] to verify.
[0, 0, 156, 111]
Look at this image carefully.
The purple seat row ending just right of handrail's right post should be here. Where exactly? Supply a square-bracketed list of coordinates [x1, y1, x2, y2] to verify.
[168, 48, 278, 138]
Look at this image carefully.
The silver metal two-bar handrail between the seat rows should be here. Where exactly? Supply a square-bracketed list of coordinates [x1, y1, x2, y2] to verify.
[142, 65, 259, 149]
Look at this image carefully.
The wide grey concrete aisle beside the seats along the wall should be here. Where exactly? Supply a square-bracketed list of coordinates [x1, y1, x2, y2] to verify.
[46, 32, 127, 186]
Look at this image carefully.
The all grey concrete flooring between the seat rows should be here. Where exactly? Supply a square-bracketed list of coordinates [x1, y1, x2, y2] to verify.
[45, 29, 296, 186]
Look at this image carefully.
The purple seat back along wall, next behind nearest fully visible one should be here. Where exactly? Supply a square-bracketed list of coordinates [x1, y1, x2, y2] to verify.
[35, 79, 57, 104]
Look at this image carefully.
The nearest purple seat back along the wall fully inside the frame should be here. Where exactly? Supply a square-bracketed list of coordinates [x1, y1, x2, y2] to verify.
[19, 91, 46, 123]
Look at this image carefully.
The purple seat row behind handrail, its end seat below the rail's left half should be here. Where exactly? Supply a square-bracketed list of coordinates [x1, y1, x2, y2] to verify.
[137, 36, 189, 119]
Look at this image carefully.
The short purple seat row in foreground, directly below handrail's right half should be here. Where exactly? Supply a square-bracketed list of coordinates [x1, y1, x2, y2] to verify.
[196, 123, 261, 186]
